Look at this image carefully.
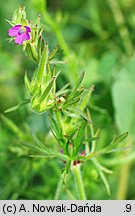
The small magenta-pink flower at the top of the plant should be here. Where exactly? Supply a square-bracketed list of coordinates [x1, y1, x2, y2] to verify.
[8, 25, 31, 45]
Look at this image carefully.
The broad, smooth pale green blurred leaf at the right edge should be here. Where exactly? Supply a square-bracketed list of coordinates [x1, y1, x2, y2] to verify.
[112, 57, 135, 132]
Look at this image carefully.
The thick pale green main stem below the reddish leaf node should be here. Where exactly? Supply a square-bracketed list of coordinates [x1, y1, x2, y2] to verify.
[73, 164, 87, 200]
